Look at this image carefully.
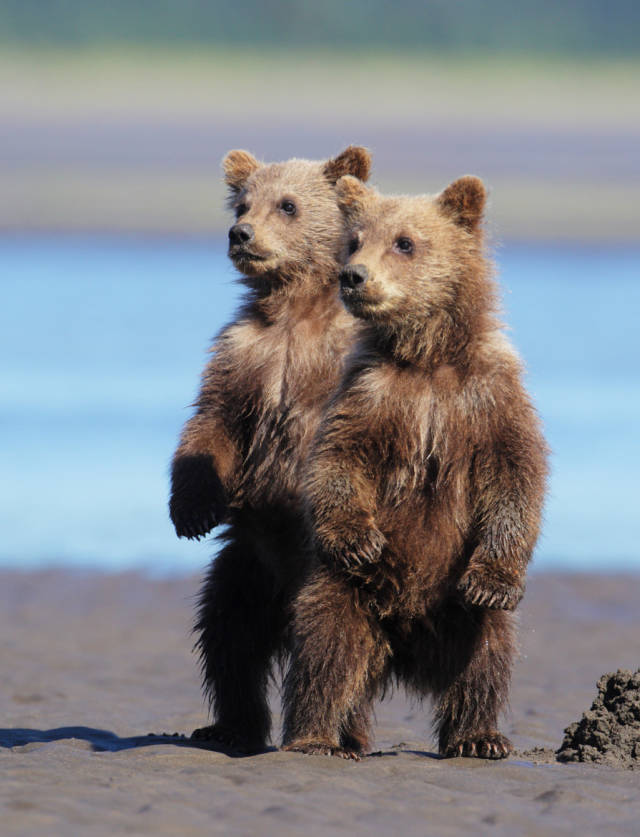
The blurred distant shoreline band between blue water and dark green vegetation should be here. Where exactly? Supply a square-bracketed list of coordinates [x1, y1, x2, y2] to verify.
[0, 48, 640, 242]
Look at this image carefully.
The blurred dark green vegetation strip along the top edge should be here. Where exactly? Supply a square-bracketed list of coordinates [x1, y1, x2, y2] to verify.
[0, 0, 640, 55]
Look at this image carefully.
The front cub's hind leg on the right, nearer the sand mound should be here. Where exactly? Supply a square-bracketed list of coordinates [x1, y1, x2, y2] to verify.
[432, 606, 514, 759]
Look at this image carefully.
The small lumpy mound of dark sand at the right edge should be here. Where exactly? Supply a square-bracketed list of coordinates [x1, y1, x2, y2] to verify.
[556, 669, 640, 768]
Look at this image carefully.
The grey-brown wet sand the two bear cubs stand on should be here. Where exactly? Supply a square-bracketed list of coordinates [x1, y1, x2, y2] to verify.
[0, 570, 640, 835]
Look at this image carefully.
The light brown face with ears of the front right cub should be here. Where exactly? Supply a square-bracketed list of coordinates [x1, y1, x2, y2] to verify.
[337, 177, 484, 329]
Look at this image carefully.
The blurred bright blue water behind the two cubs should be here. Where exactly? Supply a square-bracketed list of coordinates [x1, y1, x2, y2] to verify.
[0, 237, 640, 572]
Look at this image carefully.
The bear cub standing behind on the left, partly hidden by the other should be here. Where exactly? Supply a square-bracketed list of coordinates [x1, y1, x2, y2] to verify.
[169, 147, 370, 752]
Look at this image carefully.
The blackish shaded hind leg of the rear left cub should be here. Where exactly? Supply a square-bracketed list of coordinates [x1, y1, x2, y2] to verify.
[193, 541, 286, 753]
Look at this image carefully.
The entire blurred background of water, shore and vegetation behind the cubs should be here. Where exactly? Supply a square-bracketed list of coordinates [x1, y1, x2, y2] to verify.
[0, 0, 640, 573]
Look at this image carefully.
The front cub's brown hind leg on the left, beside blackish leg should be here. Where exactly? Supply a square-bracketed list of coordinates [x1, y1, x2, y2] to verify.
[283, 569, 389, 758]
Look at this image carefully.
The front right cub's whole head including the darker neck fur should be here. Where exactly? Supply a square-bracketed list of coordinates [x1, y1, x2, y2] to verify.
[336, 176, 494, 361]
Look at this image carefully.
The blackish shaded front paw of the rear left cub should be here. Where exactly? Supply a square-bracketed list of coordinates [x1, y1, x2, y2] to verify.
[169, 454, 227, 540]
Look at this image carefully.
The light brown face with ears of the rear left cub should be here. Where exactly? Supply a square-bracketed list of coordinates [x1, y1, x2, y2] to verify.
[223, 148, 369, 284]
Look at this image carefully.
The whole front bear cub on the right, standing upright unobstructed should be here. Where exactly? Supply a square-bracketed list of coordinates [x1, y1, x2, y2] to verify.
[284, 177, 547, 759]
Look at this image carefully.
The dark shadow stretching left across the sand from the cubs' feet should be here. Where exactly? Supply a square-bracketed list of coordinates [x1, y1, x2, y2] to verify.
[0, 726, 275, 758]
